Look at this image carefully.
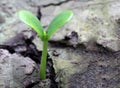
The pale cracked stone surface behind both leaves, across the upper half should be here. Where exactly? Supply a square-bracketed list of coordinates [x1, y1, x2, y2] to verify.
[0, 0, 120, 51]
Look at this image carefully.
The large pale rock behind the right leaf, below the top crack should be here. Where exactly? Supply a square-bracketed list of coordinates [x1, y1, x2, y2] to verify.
[42, 0, 120, 51]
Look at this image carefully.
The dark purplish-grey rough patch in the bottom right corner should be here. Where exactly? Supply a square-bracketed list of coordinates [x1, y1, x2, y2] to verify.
[69, 49, 120, 88]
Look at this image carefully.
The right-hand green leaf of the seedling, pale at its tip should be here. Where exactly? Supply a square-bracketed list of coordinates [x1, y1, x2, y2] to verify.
[47, 10, 73, 39]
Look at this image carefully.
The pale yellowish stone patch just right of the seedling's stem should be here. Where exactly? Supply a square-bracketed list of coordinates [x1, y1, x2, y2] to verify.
[50, 48, 88, 88]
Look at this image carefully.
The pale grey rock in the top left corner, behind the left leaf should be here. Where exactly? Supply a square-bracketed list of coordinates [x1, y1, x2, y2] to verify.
[0, 0, 37, 44]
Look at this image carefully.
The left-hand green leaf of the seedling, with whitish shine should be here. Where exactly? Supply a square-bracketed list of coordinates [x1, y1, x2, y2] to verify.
[18, 10, 44, 39]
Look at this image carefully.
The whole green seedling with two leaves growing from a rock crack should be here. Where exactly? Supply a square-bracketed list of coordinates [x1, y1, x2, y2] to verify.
[18, 10, 73, 80]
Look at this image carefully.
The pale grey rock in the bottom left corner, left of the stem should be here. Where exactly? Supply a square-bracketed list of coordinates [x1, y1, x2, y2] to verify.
[0, 49, 36, 88]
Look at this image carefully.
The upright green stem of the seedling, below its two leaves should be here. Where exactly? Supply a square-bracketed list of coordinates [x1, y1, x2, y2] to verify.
[40, 40, 48, 80]
